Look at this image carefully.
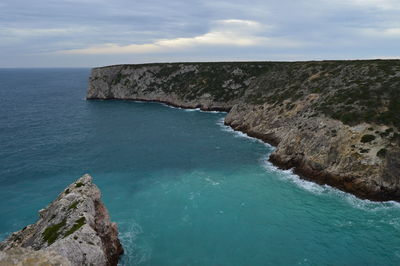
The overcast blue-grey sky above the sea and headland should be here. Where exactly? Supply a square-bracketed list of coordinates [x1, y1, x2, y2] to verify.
[0, 0, 400, 67]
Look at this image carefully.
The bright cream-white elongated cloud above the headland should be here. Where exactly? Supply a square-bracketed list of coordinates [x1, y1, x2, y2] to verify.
[58, 19, 301, 54]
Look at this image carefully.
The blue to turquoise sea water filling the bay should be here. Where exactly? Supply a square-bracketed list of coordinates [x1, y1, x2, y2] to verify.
[0, 69, 400, 265]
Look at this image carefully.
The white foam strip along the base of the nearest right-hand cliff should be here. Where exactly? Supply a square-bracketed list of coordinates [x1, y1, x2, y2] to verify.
[262, 159, 400, 211]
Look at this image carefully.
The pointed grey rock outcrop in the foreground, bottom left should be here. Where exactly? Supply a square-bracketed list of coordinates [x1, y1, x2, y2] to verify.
[0, 175, 123, 265]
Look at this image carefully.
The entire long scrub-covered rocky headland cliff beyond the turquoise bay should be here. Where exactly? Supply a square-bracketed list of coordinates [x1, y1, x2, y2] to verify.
[87, 60, 400, 200]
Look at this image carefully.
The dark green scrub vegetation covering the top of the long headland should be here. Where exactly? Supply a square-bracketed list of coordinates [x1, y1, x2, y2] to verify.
[91, 60, 400, 128]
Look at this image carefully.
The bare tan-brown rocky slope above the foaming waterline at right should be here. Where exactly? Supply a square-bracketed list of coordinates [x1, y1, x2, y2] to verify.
[225, 103, 400, 201]
